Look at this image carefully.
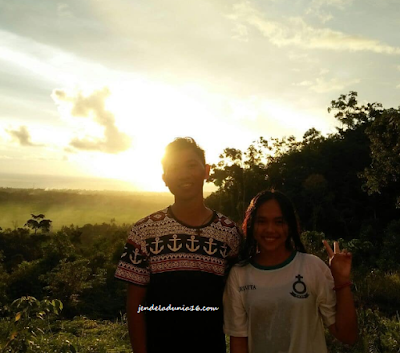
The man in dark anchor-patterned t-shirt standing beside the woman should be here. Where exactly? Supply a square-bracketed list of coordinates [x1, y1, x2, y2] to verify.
[115, 138, 240, 353]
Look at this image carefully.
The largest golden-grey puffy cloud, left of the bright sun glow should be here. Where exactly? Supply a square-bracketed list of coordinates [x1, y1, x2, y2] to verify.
[52, 87, 132, 154]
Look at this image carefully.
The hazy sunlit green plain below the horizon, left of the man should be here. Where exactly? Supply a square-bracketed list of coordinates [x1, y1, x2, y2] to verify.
[0, 188, 173, 231]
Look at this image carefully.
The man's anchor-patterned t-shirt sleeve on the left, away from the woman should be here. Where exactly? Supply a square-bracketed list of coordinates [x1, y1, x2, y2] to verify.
[115, 226, 150, 286]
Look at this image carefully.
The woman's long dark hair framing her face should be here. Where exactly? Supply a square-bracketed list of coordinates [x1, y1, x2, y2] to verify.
[239, 190, 306, 265]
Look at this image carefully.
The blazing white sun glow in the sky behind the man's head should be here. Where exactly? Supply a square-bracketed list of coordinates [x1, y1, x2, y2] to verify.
[66, 80, 253, 192]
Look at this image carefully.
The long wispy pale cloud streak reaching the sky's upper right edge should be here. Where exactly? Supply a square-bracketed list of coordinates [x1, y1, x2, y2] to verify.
[229, 2, 400, 55]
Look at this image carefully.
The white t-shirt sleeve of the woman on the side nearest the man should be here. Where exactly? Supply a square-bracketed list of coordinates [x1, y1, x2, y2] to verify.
[224, 267, 248, 337]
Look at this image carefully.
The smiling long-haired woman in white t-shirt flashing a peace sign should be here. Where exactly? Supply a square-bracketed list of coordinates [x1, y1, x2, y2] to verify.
[224, 191, 357, 353]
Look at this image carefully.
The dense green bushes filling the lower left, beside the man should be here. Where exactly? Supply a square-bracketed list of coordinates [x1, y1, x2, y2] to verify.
[0, 219, 130, 353]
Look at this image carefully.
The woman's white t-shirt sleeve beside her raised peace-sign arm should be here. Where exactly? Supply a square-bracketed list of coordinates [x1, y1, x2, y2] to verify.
[316, 257, 336, 327]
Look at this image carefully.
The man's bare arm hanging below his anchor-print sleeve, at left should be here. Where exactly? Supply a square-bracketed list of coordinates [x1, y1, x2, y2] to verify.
[126, 284, 147, 353]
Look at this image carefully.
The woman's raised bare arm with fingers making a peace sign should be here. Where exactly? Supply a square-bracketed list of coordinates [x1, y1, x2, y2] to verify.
[323, 240, 358, 344]
